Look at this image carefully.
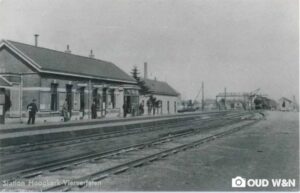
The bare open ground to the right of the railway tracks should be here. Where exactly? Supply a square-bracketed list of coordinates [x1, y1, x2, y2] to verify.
[85, 112, 299, 191]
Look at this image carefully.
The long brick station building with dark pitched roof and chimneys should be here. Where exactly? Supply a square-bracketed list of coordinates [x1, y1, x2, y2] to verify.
[0, 40, 139, 122]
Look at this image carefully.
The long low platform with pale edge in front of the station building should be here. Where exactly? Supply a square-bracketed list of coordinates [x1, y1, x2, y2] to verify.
[0, 112, 225, 148]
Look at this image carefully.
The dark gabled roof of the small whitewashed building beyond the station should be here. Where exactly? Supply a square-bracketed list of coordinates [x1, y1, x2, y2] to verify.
[143, 79, 179, 96]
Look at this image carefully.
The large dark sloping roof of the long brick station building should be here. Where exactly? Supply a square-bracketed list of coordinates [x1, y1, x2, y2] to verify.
[4, 41, 136, 83]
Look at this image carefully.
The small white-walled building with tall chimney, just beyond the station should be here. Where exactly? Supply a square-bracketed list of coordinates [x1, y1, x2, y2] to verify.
[140, 63, 180, 114]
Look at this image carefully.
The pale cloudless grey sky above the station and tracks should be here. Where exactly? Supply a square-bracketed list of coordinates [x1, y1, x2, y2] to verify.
[0, 0, 299, 100]
